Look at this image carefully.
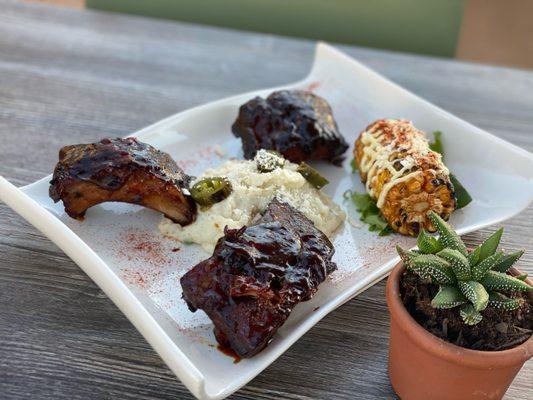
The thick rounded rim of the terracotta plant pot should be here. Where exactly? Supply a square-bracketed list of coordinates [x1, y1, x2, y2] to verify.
[386, 261, 533, 369]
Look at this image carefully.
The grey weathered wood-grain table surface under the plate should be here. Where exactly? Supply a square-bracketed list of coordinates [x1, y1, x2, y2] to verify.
[0, 0, 533, 400]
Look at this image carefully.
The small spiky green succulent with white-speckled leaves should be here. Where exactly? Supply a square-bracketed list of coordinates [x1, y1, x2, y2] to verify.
[397, 211, 533, 325]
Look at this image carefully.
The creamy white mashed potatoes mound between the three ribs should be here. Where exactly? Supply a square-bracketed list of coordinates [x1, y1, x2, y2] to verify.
[159, 152, 346, 252]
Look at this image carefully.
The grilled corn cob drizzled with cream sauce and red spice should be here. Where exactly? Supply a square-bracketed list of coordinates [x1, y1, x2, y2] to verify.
[354, 119, 456, 236]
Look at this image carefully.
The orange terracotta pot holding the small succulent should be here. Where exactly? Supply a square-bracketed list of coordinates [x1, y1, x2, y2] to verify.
[387, 263, 533, 400]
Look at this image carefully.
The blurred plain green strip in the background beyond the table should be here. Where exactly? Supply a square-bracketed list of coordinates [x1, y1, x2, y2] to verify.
[87, 0, 465, 57]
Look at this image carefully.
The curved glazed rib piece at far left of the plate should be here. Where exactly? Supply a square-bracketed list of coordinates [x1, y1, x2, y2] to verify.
[50, 138, 196, 225]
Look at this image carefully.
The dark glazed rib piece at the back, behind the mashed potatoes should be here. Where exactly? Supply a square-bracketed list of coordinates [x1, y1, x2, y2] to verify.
[231, 90, 348, 165]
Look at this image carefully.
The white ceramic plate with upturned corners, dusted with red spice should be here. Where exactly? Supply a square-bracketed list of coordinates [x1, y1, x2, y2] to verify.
[0, 44, 533, 399]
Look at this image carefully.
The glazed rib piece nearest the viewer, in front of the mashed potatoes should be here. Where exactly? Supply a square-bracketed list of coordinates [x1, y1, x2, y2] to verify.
[181, 199, 337, 357]
